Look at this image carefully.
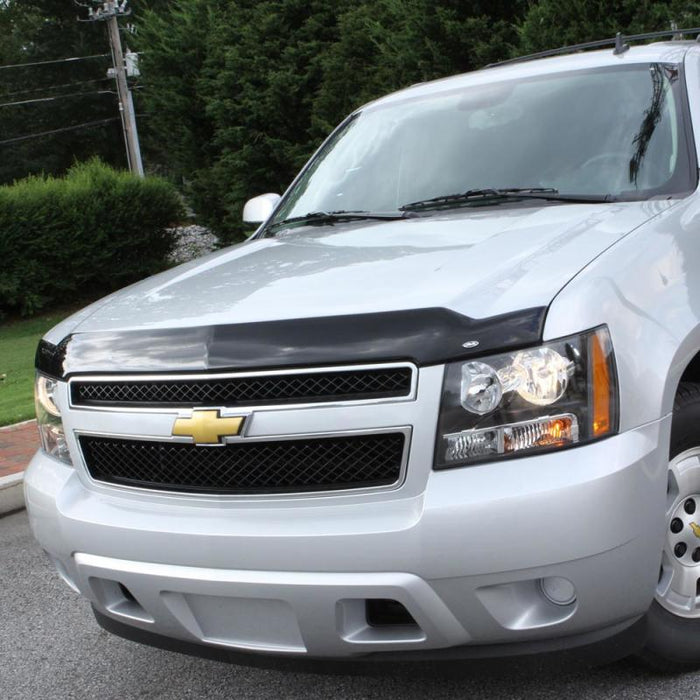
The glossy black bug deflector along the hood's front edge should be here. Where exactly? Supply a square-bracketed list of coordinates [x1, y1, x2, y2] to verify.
[36, 307, 547, 379]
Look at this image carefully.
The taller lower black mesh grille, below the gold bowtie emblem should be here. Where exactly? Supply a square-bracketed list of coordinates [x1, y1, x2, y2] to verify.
[80, 433, 405, 494]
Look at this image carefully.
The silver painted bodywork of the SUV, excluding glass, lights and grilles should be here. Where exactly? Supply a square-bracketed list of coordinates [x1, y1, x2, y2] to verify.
[26, 44, 700, 657]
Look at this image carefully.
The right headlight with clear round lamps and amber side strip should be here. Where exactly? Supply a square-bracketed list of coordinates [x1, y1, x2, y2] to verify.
[435, 327, 618, 469]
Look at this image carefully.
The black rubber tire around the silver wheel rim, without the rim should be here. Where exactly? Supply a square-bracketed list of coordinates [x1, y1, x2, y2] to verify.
[639, 383, 700, 673]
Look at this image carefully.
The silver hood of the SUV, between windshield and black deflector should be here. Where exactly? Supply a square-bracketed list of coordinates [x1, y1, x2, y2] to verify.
[47, 201, 671, 342]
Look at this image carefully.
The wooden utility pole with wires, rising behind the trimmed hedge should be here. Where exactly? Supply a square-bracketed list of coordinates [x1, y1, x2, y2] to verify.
[78, 0, 143, 177]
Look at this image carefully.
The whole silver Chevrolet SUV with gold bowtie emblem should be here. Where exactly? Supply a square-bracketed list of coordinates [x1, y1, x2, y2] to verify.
[25, 35, 700, 669]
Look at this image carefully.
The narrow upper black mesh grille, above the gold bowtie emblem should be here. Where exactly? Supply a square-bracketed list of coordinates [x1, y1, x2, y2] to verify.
[71, 367, 411, 407]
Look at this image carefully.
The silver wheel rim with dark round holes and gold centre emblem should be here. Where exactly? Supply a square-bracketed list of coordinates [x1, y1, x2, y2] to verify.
[656, 447, 700, 618]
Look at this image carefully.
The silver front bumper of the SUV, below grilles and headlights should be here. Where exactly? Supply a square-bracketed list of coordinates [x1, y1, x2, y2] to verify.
[25, 418, 670, 658]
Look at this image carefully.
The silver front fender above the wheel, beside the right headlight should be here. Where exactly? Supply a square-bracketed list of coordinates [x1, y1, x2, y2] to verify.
[543, 197, 700, 431]
